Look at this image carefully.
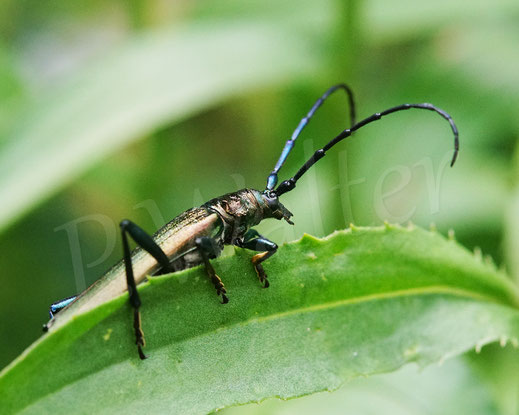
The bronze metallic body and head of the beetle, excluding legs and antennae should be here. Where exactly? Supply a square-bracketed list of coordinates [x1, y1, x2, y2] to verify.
[45, 189, 292, 340]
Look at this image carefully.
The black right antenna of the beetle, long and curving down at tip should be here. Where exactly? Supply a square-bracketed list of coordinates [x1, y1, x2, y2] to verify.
[274, 103, 459, 196]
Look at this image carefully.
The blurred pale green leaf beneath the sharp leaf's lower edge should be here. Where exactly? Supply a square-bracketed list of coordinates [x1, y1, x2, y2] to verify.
[221, 358, 500, 415]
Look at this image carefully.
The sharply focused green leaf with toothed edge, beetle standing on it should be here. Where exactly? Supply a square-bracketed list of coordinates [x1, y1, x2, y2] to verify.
[0, 225, 519, 414]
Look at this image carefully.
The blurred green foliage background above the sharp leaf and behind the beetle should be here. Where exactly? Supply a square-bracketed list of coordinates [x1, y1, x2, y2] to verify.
[0, 0, 519, 412]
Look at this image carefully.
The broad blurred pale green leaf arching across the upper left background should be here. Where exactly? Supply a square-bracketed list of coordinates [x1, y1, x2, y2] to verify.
[0, 16, 328, 230]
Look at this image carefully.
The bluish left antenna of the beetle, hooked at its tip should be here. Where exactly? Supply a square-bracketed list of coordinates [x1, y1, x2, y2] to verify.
[267, 84, 355, 191]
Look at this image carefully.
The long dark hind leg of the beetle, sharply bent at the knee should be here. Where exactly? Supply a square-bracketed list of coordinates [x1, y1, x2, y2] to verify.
[120, 220, 173, 360]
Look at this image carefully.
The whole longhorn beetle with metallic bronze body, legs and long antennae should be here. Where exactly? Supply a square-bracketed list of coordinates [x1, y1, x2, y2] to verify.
[44, 84, 459, 359]
